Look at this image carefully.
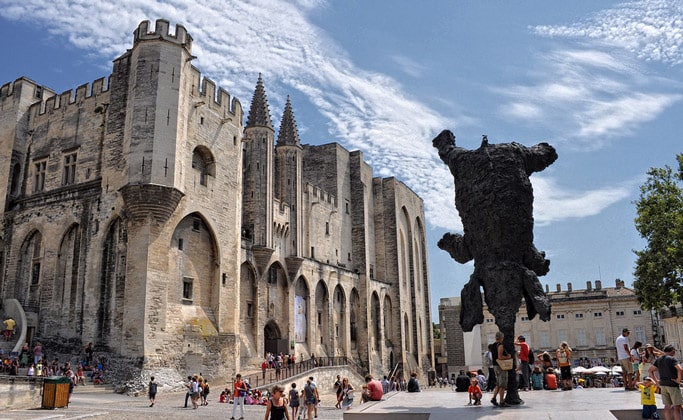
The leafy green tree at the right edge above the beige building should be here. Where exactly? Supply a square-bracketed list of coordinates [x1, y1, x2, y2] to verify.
[633, 154, 683, 309]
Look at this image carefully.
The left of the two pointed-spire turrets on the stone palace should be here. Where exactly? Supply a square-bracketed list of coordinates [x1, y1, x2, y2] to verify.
[242, 74, 275, 248]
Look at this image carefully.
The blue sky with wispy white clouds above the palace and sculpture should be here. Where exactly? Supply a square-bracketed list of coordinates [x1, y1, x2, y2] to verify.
[0, 0, 683, 321]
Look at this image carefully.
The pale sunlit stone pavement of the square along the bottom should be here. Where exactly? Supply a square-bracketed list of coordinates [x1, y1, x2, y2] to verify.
[0, 387, 648, 420]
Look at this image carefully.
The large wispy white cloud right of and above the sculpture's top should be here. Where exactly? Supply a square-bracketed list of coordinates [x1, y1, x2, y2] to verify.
[494, 48, 683, 151]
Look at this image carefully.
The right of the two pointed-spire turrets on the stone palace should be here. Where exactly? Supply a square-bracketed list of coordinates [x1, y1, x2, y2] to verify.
[275, 96, 303, 255]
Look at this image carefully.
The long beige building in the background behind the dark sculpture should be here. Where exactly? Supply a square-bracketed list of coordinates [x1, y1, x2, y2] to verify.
[439, 279, 664, 373]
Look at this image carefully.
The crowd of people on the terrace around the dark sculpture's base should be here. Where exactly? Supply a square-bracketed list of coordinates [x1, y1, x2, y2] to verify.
[464, 328, 683, 420]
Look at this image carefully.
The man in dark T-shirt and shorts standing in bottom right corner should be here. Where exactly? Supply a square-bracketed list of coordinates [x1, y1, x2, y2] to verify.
[648, 344, 683, 420]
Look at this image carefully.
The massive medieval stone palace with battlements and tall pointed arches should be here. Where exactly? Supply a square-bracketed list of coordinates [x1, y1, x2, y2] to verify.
[0, 20, 433, 376]
